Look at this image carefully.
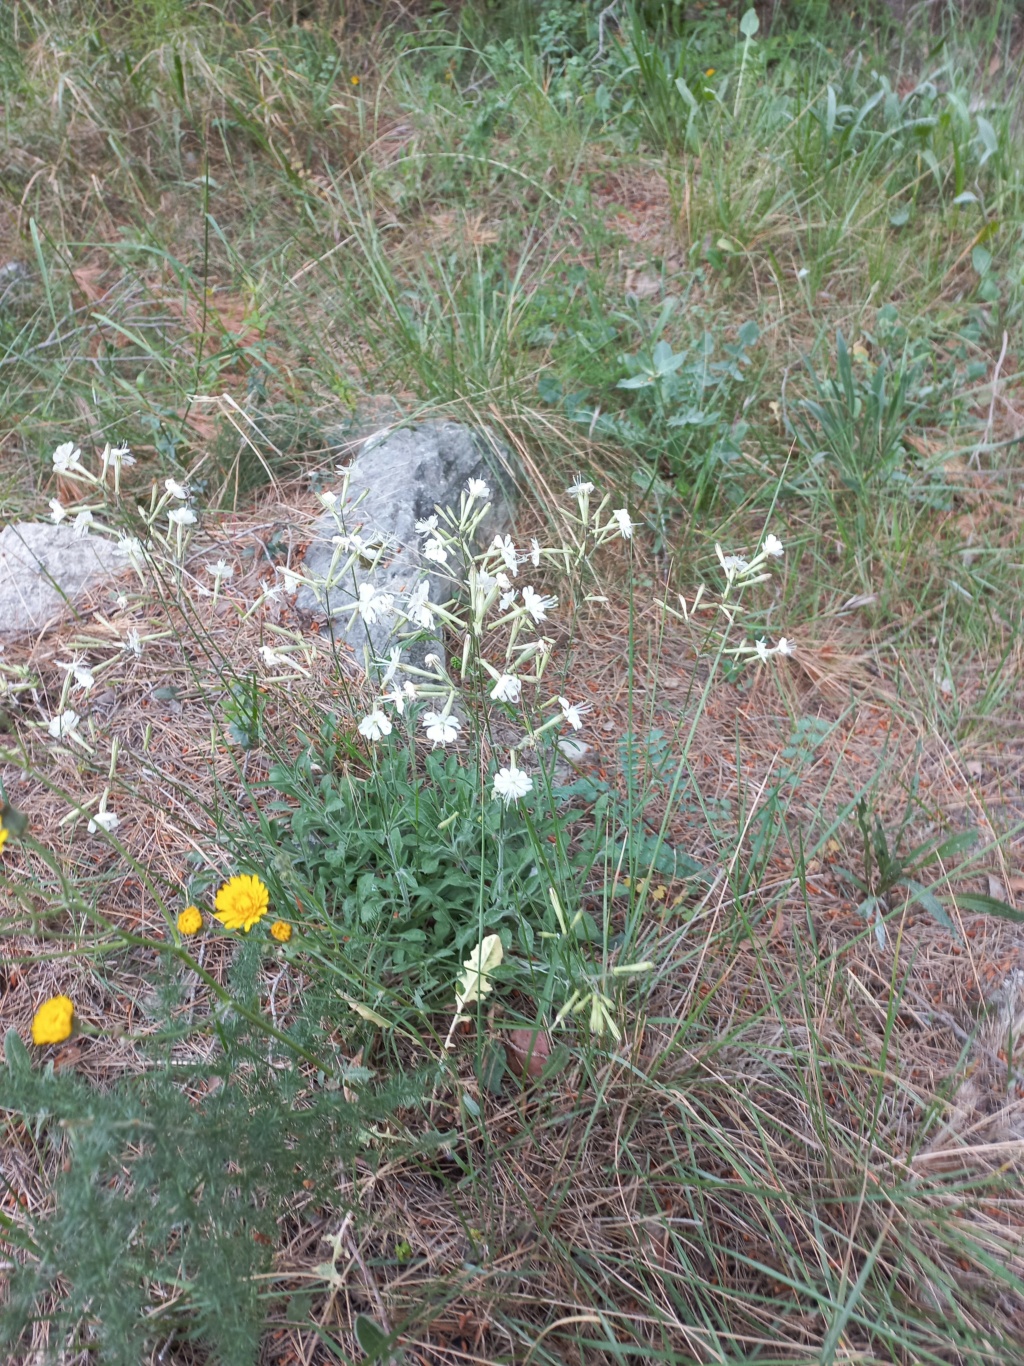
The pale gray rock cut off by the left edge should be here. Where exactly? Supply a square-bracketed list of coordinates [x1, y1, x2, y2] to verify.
[0, 522, 124, 641]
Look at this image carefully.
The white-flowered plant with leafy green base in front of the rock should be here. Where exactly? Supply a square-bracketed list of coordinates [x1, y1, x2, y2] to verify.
[262, 477, 792, 1046]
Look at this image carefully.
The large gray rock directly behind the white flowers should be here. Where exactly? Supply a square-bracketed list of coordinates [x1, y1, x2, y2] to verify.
[296, 422, 515, 671]
